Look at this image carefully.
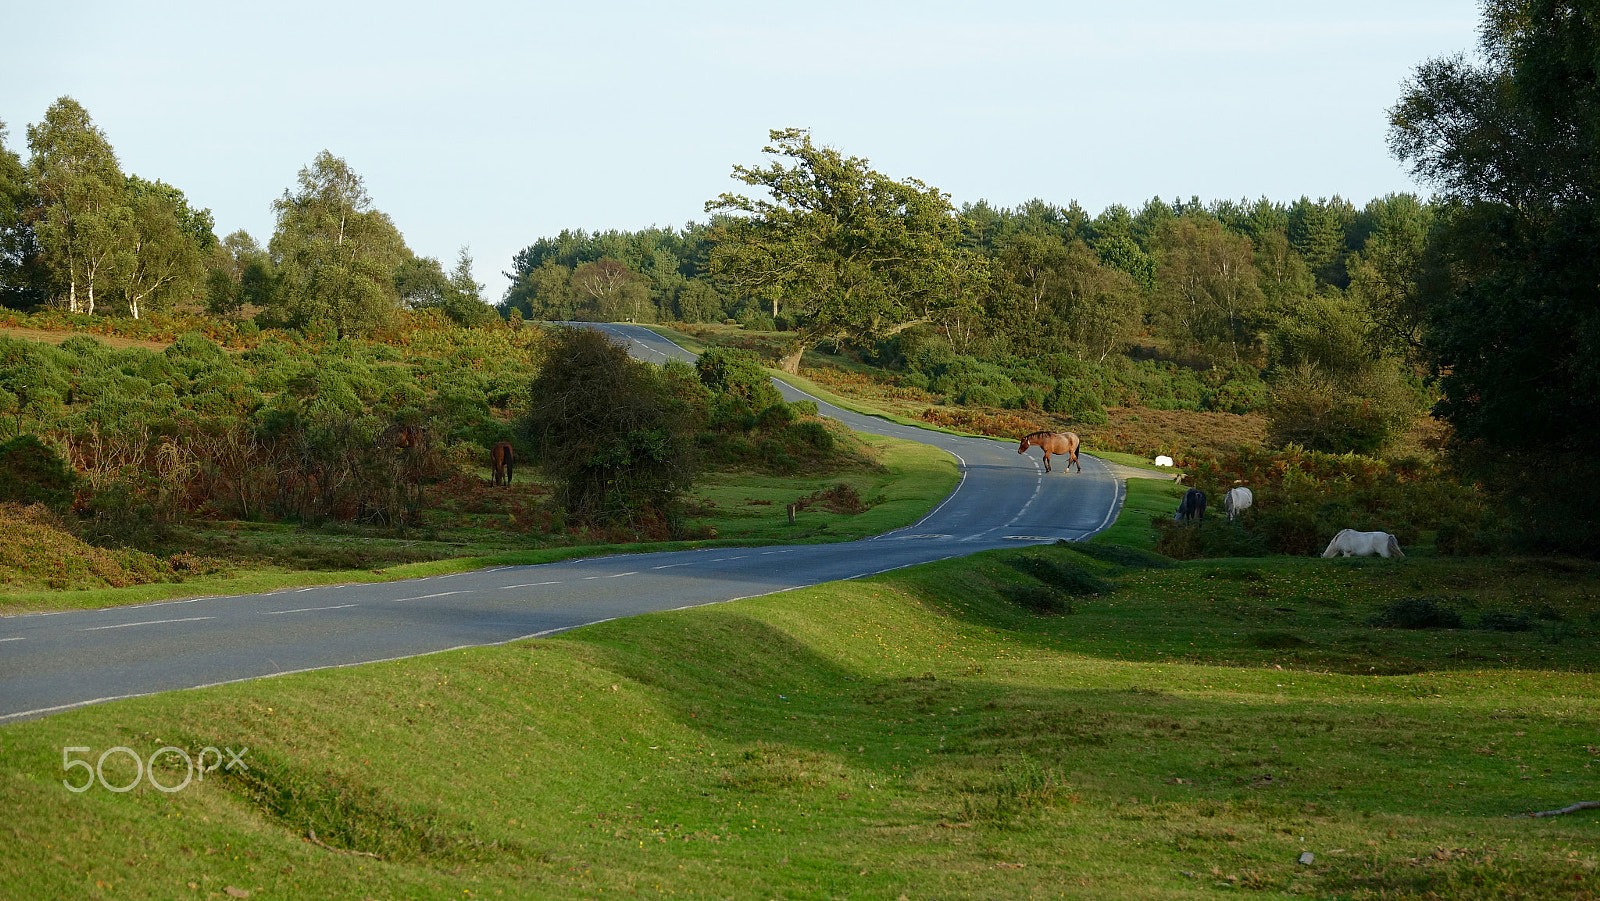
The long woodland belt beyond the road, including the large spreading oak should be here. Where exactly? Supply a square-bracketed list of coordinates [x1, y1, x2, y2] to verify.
[499, 130, 1438, 451]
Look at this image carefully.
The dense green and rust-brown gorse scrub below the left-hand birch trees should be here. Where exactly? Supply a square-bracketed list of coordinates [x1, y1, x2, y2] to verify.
[0, 315, 544, 541]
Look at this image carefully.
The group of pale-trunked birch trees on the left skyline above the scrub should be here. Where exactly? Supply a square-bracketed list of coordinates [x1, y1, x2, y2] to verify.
[0, 98, 494, 336]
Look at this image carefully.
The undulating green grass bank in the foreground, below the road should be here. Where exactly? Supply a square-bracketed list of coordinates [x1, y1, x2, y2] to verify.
[0, 544, 1600, 899]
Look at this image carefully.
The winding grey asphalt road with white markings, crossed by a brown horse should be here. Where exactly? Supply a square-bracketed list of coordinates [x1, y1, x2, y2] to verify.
[0, 325, 1122, 723]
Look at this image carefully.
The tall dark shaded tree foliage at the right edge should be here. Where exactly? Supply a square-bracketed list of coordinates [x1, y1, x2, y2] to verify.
[1389, 0, 1600, 554]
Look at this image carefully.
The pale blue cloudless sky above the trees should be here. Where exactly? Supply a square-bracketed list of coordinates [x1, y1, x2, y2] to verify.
[0, 0, 1480, 301]
